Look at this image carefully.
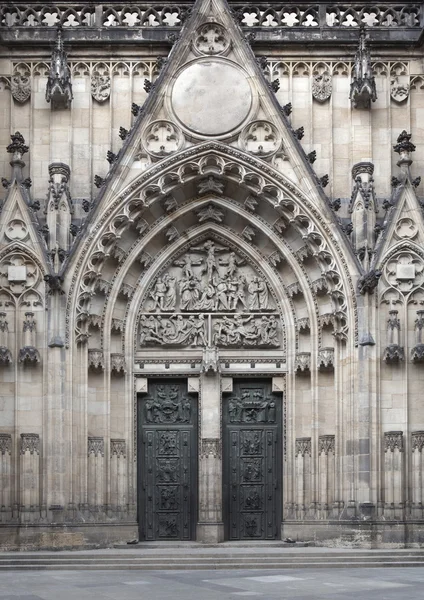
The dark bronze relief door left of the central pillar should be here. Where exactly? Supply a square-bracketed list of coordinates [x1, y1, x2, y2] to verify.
[138, 380, 197, 540]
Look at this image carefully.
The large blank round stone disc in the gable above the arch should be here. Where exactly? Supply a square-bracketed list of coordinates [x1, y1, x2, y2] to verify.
[171, 60, 252, 136]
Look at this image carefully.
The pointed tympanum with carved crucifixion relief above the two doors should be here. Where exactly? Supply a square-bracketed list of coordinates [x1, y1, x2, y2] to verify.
[139, 239, 281, 348]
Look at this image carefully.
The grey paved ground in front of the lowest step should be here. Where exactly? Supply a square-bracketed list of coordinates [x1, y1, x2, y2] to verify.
[0, 567, 424, 600]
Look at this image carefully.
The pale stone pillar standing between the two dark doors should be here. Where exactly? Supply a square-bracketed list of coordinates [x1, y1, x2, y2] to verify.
[197, 371, 224, 543]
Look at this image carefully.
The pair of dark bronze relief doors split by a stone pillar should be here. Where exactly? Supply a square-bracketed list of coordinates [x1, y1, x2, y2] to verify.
[138, 379, 281, 540]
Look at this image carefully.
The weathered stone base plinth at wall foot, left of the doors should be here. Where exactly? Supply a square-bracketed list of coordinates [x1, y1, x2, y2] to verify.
[0, 523, 138, 550]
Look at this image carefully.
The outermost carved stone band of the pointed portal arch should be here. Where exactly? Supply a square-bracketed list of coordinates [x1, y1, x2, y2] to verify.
[68, 142, 356, 346]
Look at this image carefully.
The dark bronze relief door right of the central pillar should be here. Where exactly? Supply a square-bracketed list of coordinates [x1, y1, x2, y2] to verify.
[223, 380, 281, 540]
